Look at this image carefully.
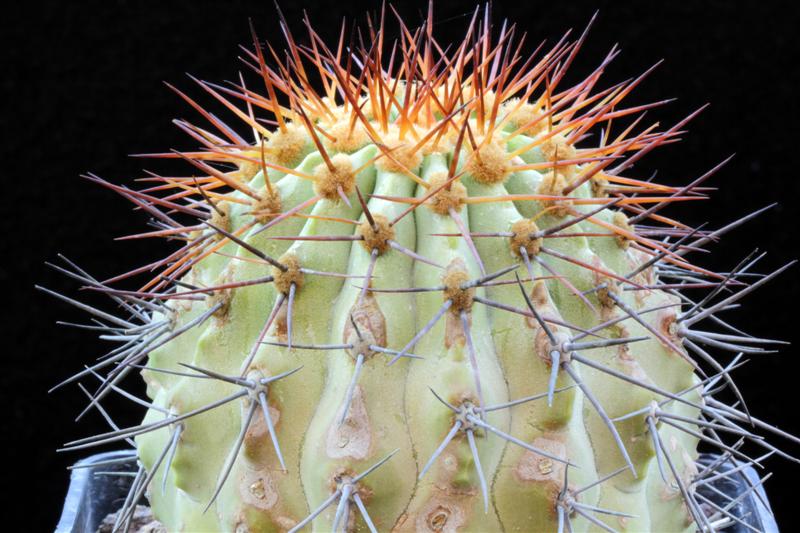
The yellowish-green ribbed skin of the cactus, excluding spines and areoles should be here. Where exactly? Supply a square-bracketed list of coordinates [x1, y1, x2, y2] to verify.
[137, 121, 700, 533]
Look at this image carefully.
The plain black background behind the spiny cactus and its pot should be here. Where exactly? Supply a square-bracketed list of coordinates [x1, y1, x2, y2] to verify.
[0, 0, 800, 531]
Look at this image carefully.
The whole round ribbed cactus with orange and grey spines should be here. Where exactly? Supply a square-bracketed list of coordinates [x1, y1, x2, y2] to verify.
[44, 5, 798, 533]
